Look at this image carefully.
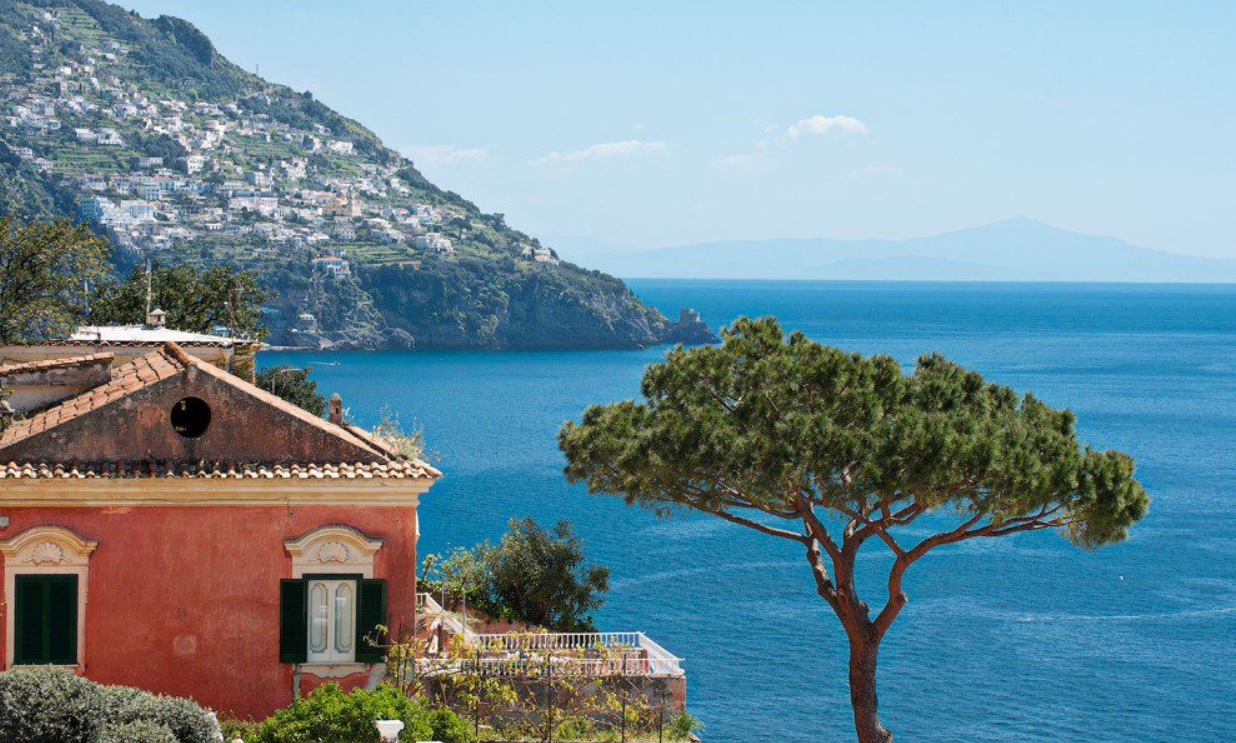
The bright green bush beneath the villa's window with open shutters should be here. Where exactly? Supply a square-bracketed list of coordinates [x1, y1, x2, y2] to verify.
[246, 684, 473, 743]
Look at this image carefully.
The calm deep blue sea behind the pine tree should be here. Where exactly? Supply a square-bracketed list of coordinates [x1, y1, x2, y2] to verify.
[262, 281, 1236, 743]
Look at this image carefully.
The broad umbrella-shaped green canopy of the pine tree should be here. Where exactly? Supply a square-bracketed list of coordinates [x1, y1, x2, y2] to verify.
[559, 318, 1148, 548]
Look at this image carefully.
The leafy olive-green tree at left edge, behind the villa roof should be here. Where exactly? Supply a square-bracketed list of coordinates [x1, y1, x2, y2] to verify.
[0, 216, 108, 344]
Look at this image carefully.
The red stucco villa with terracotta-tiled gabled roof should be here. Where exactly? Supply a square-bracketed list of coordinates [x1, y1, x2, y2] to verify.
[0, 342, 441, 717]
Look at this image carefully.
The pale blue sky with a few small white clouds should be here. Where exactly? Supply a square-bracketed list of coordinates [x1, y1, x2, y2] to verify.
[122, 0, 1236, 257]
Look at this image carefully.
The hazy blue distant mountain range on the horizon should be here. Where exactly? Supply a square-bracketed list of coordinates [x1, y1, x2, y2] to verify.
[583, 218, 1236, 283]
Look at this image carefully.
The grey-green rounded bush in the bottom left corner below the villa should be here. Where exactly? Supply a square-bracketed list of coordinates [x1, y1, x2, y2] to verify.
[0, 668, 219, 743]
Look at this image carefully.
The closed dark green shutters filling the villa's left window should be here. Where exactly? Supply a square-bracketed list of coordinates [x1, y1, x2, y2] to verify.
[14, 575, 78, 665]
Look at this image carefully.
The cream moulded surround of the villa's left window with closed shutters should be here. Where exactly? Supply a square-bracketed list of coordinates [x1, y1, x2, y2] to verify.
[0, 525, 99, 670]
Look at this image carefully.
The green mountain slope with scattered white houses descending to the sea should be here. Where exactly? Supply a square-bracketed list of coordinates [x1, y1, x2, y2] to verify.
[0, 0, 712, 349]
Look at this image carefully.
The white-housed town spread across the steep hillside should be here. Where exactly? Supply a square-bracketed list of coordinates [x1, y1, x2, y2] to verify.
[0, 9, 559, 276]
